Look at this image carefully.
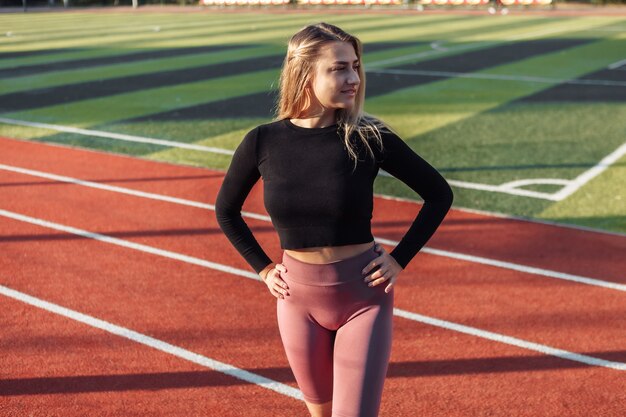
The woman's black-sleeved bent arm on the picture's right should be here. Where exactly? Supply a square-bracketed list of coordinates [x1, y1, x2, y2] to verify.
[379, 132, 453, 269]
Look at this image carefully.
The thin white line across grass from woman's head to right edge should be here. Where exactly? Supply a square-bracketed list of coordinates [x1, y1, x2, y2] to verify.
[368, 68, 626, 87]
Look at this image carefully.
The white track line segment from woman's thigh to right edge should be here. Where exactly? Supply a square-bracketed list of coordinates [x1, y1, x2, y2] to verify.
[393, 308, 626, 371]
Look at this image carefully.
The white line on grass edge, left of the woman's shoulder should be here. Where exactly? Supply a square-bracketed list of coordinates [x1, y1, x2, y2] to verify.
[0, 117, 234, 155]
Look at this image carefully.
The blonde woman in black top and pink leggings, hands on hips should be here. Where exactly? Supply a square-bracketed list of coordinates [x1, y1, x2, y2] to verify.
[216, 23, 452, 417]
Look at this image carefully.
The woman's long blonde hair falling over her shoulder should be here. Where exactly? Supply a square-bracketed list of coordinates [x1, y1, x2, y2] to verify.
[275, 22, 391, 169]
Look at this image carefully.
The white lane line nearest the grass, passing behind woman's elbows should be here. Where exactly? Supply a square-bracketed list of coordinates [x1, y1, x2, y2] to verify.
[0, 164, 626, 291]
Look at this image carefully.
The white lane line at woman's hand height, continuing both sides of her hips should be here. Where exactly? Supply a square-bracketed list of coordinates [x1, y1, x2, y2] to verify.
[0, 209, 626, 370]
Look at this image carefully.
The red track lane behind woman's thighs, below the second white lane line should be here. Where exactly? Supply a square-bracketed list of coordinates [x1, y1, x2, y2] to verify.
[0, 219, 622, 416]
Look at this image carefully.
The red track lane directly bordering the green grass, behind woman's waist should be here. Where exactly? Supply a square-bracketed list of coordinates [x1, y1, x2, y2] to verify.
[0, 139, 626, 283]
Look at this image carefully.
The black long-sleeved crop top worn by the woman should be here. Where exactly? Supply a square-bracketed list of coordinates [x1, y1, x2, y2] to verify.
[215, 119, 452, 273]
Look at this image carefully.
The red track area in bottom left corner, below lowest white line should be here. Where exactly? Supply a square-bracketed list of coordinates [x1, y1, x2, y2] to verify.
[0, 296, 301, 417]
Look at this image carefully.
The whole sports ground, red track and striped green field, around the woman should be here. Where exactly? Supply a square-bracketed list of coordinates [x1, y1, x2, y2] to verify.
[0, 8, 626, 417]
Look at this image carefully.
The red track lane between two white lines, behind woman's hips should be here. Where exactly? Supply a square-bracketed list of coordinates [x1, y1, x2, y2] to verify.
[2, 163, 626, 362]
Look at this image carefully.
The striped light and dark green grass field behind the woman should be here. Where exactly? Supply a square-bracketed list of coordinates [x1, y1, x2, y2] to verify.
[0, 11, 626, 233]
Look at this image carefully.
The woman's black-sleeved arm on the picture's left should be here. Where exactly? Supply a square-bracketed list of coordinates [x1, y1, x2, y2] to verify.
[215, 128, 272, 277]
